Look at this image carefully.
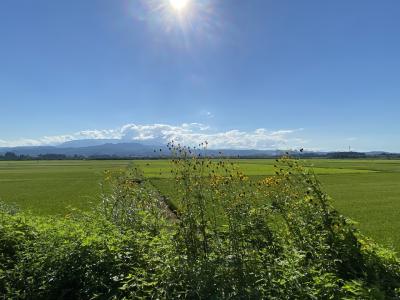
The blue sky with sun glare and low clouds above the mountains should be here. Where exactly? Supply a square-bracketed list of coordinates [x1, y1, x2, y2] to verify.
[0, 0, 400, 152]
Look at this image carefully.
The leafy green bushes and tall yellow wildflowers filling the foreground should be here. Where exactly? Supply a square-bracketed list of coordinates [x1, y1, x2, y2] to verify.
[0, 148, 400, 299]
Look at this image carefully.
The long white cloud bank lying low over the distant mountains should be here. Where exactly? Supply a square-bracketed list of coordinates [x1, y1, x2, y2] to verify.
[0, 123, 306, 149]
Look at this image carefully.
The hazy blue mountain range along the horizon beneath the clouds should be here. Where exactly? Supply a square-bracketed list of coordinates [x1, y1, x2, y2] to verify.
[0, 139, 396, 158]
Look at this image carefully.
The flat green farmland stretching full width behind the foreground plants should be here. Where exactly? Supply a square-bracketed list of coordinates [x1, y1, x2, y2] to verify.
[0, 159, 400, 251]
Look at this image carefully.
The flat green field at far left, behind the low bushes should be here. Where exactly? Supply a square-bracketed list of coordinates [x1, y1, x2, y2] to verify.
[0, 161, 129, 215]
